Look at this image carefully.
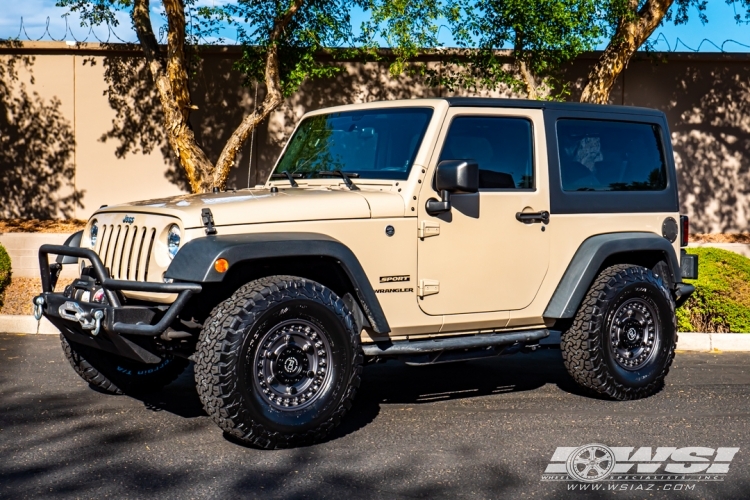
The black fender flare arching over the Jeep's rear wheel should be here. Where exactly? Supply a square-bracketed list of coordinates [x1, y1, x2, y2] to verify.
[542, 232, 682, 319]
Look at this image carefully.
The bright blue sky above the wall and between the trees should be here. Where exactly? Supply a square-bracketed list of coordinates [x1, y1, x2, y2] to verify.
[0, 0, 750, 52]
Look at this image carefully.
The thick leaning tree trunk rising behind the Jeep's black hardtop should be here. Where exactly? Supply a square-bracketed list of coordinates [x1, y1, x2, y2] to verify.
[581, 0, 674, 104]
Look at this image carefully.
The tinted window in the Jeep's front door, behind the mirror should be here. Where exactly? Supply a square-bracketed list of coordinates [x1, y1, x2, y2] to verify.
[439, 116, 534, 189]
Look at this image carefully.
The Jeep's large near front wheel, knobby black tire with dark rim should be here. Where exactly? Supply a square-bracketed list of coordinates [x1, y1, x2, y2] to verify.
[195, 276, 362, 448]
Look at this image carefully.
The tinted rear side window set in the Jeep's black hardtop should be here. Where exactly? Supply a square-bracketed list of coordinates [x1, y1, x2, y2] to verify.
[557, 120, 667, 191]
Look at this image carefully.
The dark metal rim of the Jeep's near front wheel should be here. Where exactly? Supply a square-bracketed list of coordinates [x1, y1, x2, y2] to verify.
[252, 319, 331, 411]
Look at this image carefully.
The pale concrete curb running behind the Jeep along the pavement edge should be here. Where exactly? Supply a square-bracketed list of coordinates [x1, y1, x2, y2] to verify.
[0, 314, 750, 352]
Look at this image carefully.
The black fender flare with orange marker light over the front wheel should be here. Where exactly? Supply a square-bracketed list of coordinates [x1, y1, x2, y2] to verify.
[165, 233, 391, 334]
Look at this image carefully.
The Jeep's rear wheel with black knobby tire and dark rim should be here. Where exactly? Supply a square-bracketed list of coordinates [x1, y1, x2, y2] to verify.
[560, 265, 677, 400]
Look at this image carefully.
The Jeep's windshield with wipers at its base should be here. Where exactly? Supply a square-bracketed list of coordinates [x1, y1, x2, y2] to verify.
[274, 108, 432, 180]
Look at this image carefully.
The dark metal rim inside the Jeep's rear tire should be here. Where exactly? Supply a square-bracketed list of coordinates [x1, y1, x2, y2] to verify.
[609, 297, 661, 370]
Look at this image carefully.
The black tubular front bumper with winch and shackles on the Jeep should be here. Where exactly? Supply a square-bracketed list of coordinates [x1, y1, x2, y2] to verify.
[34, 245, 202, 363]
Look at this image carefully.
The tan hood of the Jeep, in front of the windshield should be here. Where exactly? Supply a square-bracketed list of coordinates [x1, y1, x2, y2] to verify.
[98, 188, 404, 228]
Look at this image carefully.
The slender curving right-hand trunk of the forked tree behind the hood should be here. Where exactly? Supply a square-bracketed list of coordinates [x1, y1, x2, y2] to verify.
[213, 0, 305, 188]
